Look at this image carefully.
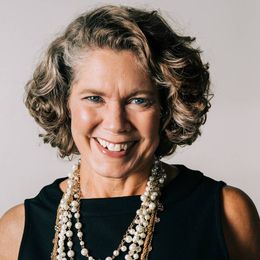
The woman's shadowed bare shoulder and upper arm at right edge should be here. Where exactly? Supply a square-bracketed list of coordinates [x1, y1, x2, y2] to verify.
[222, 186, 260, 260]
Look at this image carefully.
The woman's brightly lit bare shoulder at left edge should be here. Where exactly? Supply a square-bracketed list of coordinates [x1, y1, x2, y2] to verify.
[0, 204, 25, 260]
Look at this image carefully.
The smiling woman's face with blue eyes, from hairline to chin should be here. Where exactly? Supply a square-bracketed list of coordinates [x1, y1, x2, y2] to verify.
[69, 49, 160, 178]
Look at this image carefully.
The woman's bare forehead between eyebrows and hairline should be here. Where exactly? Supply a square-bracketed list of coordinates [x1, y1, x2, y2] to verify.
[74, 49, 152, 93]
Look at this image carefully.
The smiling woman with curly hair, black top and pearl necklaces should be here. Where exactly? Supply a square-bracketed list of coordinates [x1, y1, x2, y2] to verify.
[0, 6, 260, 260]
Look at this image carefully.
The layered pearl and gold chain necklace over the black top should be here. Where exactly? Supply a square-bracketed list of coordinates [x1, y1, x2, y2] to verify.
[51, 158, 166, 260]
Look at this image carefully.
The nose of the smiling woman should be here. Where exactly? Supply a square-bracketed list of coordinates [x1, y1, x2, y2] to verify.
[102, 102, 131, 135]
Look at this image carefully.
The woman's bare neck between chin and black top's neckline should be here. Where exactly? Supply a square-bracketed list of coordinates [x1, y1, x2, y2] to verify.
[80, 163, 150, 198]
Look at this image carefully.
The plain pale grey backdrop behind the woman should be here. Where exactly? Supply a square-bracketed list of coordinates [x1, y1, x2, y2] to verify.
[0, 0, 260, 215]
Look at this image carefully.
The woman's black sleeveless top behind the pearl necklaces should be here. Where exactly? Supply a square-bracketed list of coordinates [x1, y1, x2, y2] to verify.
[18, 165, 228, 260]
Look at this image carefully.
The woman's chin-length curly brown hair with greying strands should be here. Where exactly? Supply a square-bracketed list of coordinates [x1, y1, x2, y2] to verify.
[25, 5, 210, 158]
